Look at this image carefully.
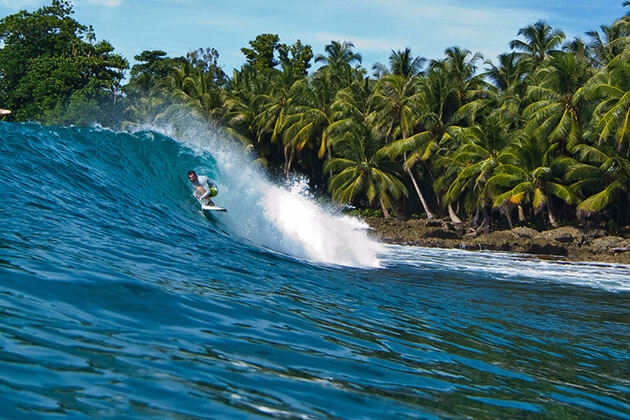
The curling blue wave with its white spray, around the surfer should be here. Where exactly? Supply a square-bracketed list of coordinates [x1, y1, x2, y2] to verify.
[0, 120, 382, 267]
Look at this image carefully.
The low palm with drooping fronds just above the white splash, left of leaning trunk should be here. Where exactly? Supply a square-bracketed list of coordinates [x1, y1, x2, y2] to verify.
[324, 118, 407, 217]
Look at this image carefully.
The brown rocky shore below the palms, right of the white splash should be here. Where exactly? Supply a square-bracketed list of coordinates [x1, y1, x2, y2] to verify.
[364, 217, 630, 265]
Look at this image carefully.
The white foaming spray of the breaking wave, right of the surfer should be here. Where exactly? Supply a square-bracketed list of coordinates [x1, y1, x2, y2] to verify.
[133, 117, 384, 267]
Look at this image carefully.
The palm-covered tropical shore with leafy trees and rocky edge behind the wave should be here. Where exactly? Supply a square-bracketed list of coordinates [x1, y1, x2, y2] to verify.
[0, 0, 630, 264]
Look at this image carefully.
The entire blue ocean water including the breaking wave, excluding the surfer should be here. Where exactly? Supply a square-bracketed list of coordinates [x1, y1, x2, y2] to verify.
[0, 123, 630, 419]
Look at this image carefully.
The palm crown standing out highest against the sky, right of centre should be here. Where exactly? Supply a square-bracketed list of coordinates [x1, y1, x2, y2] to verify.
[510, 21, 565, 65]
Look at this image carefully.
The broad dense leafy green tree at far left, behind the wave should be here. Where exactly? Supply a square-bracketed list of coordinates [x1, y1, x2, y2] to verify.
[0, 0, 128, 123]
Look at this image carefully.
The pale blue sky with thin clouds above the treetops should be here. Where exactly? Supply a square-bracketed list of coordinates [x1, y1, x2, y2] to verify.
[0, 0, 630, 75]
